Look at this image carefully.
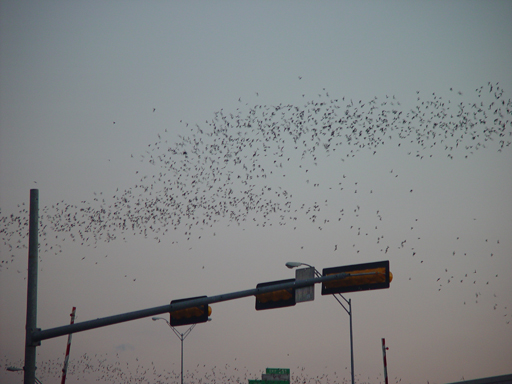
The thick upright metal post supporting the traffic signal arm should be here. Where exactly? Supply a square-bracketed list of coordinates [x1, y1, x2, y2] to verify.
[23, 189, 39, 384]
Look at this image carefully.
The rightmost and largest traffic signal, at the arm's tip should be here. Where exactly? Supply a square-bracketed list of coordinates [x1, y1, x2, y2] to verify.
[322, 260, 393, 295]
